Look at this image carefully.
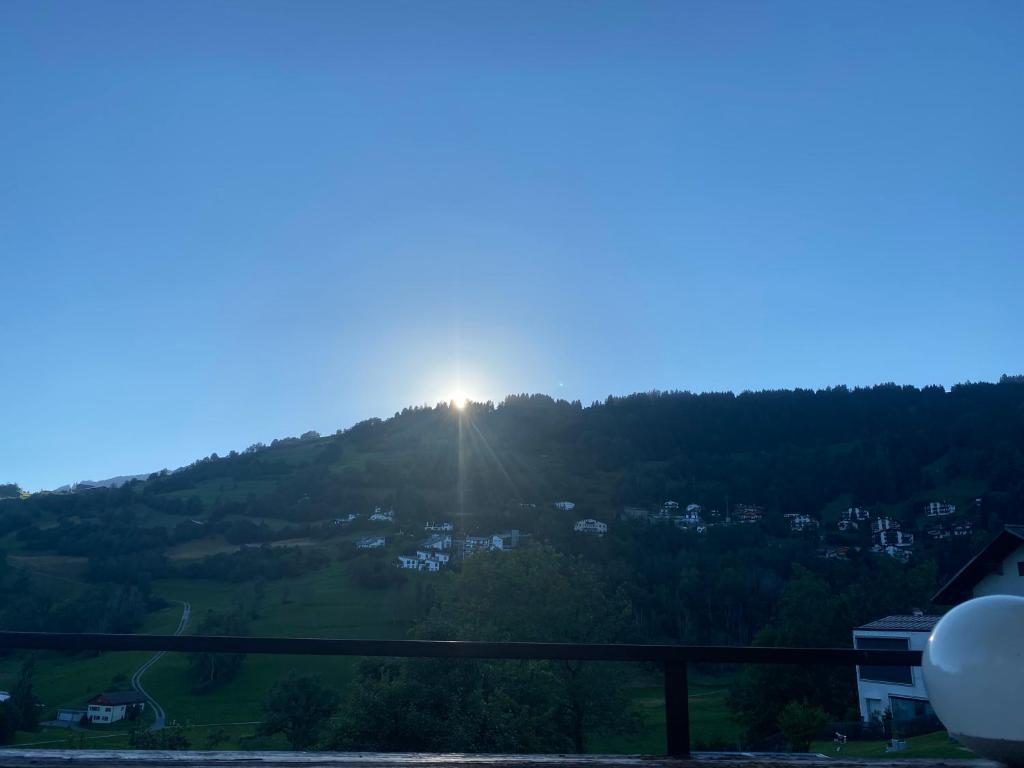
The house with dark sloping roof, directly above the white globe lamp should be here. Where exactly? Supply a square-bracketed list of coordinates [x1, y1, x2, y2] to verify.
[932, 525, 1024, 605]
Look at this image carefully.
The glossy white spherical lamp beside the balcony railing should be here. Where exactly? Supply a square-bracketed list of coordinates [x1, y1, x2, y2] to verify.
[922, 595, 1024, 767]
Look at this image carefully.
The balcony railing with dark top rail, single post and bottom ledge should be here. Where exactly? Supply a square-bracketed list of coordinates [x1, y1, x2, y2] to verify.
[0, 632, 937, 768]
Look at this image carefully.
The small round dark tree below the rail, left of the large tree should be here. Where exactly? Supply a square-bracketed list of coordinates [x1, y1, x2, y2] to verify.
[259, 672, 338, 750]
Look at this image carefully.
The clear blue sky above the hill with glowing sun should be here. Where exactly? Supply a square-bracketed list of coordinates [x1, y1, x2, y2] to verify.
[0, 0, 1024, 489]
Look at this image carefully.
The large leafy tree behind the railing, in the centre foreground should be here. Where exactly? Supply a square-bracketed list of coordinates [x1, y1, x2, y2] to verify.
[328, 546, 634, 752]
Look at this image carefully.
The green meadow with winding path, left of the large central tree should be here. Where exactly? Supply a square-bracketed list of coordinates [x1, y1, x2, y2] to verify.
[0, 562, 422, 745]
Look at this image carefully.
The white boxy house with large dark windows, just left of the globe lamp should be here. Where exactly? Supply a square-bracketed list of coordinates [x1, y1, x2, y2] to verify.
[853, 612, 941, 723]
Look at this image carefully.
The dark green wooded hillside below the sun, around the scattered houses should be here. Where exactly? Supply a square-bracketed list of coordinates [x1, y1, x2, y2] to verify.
[0, 379, 1024, 751]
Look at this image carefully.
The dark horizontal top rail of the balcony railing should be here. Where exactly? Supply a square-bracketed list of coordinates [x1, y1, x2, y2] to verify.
[0, 632, 921, 667]
